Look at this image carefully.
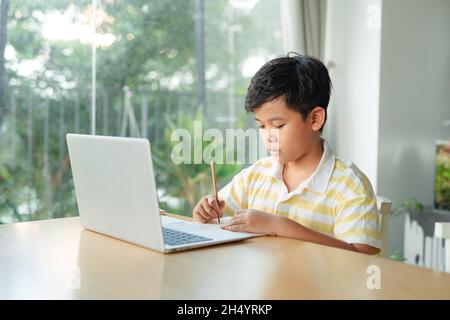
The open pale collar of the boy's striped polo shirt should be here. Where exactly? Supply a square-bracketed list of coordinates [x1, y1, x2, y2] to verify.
[271, 139, 336, 194]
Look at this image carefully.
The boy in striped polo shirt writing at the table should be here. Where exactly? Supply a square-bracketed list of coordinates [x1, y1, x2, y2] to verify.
[193, 55, 381, 254]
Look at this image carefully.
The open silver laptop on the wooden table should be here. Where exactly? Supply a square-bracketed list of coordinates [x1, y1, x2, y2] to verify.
[66, 133, 258, 253]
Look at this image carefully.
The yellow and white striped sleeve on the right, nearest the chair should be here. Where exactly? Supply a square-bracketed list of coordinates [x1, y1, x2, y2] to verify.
[334, 194, 382, 249]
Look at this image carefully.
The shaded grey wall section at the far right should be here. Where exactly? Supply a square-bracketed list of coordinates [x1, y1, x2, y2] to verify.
[378, 0, 450, 255]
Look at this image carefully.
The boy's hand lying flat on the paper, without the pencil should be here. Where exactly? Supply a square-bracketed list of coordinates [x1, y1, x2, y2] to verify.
[222, 209, 280, 236]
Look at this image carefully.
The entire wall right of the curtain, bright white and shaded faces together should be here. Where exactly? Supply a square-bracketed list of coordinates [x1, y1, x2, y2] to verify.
[325, 0, 450, 251]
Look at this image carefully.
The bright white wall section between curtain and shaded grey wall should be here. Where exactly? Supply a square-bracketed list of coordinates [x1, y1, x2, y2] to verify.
[324, 0, 381, 191]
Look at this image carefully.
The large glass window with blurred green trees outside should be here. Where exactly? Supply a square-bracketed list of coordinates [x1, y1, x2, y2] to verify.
[0, 0, 282, 223]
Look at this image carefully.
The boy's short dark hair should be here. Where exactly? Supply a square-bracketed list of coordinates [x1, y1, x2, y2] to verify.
[245, 53, 332, 131]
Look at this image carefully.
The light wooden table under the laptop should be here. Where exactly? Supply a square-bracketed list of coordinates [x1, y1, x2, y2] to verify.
[0, 217, 450, 299]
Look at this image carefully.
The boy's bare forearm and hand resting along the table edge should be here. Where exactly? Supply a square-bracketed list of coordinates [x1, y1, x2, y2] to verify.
[223, 209, 379, 254]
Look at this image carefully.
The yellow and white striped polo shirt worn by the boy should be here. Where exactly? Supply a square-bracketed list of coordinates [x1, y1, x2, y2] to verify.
[219, 140, 381, 248]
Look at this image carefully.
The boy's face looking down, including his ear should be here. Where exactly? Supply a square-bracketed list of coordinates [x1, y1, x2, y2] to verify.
[254, 98, 324, 164]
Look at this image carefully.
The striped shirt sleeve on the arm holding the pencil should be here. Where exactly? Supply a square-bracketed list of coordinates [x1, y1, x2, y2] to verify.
[218, 168, 249, 216]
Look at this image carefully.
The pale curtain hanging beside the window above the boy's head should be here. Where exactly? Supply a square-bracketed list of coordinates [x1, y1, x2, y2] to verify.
[281, 0, 326, 59]
